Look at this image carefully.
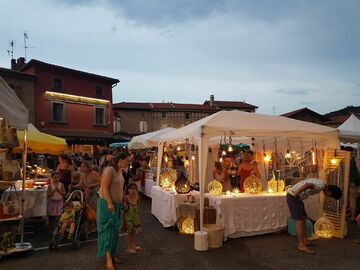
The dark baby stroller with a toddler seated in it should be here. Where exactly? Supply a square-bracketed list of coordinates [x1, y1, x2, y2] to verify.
[49, 190, 85, 250]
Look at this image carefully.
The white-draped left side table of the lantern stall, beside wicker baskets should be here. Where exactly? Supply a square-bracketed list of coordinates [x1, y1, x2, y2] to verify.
[151, 186, 200, 227]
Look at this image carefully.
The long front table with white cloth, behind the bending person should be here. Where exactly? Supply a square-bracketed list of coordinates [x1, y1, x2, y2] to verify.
[205, 192, 320, 239]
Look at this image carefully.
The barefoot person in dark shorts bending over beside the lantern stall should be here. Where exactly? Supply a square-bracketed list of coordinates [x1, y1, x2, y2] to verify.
[286, 178, 342, 254]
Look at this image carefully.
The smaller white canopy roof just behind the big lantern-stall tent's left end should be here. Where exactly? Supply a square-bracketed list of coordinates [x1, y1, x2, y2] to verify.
[128, 128, 176, 149]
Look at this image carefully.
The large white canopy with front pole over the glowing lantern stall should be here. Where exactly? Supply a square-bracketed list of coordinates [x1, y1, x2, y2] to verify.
[159, 111, 339, 236]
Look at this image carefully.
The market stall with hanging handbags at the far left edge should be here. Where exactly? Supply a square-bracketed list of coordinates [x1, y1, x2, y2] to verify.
[0, 77, 32, 257]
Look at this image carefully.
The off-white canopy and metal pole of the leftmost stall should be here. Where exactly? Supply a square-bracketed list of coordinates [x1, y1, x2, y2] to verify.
[0, 77, 32, 252]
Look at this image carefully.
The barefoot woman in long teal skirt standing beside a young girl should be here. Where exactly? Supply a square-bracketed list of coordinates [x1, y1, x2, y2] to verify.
[96, 153, 128, 269]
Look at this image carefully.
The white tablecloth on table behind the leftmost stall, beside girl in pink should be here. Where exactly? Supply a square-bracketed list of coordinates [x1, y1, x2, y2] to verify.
[2, 189, 47, 218]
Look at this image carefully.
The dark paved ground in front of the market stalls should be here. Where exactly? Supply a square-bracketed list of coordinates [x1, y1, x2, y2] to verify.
[0, 196, 360, 270]
